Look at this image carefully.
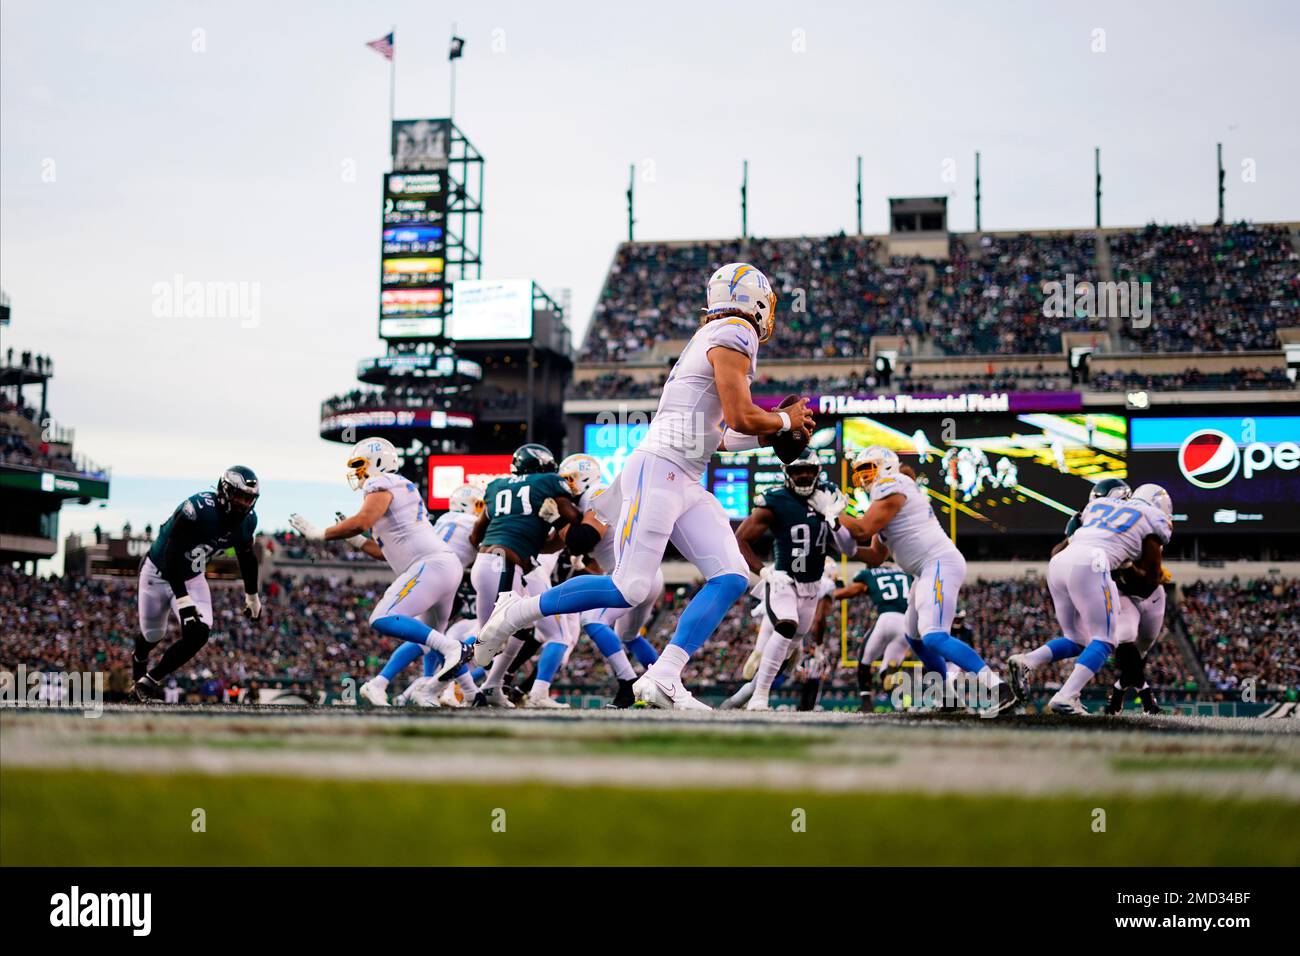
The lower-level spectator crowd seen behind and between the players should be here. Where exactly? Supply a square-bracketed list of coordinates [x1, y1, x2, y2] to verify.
[0, 567, 1300, 702]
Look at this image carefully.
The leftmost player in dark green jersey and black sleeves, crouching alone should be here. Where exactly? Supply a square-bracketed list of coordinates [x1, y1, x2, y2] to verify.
[131, 464, 261, 701]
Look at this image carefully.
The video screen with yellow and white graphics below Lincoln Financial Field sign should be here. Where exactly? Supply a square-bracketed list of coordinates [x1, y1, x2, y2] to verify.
[842, 412, 1128, 533]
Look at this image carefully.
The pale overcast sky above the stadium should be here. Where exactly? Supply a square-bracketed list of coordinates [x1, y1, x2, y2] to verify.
[0, 0, 1300, 561]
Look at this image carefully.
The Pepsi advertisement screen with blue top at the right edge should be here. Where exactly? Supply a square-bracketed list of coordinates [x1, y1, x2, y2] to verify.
[1128, 415, 1300, 532]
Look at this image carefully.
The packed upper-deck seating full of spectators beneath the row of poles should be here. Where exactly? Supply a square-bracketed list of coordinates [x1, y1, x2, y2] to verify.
[580, 222, 1300, 363]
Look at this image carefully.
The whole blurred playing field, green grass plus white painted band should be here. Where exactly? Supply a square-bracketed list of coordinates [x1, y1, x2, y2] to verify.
[0, 708, 1300, 866]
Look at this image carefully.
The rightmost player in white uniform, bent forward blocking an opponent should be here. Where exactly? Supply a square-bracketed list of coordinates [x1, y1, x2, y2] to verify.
[1008, 480, 1174, 715]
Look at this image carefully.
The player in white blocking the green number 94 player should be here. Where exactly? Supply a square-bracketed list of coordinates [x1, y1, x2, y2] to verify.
[844, 445, 1017, 717]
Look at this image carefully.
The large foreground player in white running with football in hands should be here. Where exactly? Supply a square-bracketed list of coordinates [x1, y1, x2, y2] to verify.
[478, 263, 814, 709]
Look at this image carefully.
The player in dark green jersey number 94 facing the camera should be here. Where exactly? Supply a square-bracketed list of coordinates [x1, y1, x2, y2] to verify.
[736, 449, 858, 710]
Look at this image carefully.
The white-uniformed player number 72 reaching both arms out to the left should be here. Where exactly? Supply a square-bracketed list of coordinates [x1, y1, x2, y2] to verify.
[289, 438, 472, 706]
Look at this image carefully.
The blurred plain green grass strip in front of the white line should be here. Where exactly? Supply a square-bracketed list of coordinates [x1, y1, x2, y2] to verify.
[0, 765, 1300, 866]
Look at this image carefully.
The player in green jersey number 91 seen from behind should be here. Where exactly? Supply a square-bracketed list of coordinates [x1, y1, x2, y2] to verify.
[469, 442, 601, 708]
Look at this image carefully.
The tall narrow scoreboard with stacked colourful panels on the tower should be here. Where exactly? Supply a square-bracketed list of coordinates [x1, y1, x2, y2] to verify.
[380, 170, 447, 339]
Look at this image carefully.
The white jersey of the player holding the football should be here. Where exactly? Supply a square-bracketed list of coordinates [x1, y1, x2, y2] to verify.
[640, 316, 758, 481]
